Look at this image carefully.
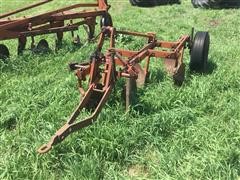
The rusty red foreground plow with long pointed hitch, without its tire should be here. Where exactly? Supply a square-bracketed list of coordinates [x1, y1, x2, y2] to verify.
[38, 27, 192, 154]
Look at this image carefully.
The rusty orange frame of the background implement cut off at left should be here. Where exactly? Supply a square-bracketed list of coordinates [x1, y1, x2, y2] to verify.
[0, 0, 110, 54]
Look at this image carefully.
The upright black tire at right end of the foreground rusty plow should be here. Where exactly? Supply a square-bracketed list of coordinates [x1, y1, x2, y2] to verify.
[190, 32, 210, 73]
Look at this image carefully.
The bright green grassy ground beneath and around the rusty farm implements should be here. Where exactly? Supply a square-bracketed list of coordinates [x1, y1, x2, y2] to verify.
[0, 0, 240, 179]
